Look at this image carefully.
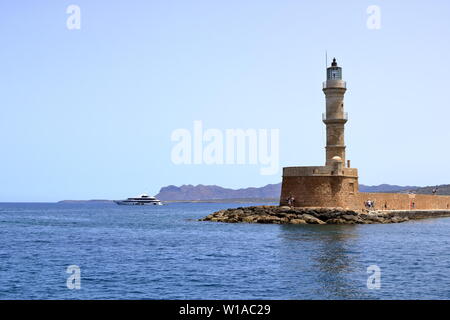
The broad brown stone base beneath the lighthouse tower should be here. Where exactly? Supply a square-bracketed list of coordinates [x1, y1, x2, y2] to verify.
[280, 166, 358, 208]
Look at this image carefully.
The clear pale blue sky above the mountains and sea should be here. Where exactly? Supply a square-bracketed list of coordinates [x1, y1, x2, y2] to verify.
[0, 0, 450, 202]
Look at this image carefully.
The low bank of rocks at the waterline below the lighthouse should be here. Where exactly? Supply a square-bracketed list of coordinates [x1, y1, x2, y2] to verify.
[200, 206, 409, 224]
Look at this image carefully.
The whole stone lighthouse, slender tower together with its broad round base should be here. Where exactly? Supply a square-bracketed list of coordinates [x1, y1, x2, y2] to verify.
[280, 59, 359, 208]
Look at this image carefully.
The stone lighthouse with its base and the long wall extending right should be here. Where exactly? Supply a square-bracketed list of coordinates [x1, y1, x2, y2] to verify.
[280, 58, 450, 211]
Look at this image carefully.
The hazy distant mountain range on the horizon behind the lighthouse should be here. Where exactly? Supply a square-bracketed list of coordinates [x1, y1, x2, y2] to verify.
[156, 183, 432, 201]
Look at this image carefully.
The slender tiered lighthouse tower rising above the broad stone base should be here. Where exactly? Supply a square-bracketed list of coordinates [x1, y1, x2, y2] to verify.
[322, 58, 348, 166]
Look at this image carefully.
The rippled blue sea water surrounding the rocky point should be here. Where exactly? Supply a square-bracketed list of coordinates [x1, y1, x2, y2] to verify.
[0, 203, 450, 299]
